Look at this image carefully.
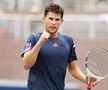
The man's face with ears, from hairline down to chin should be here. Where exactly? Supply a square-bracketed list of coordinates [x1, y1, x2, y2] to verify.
[43, 12, 63, 34]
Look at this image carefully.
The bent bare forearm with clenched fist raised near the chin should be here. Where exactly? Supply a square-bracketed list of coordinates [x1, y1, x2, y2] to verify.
[22, 32, 50, 70]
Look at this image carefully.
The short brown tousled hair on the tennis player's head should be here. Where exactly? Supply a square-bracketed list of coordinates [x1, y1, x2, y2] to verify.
[44, 3, 64, 19]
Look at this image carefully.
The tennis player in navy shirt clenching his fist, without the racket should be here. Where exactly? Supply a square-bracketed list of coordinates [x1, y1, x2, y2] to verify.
[22, 3, 96, 90]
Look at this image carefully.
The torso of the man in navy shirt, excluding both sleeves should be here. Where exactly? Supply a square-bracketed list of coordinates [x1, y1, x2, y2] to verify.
[24, 32, 77, 90]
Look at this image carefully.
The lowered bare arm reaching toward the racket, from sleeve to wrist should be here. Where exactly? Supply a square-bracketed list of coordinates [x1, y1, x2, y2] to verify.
[68, 61, 87, 83]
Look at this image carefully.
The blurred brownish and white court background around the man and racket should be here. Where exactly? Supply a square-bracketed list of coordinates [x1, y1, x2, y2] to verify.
[0, 0, 108, 90]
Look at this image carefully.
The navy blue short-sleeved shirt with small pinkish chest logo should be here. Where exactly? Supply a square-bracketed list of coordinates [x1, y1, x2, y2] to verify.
[22, 33, 77, 90]
